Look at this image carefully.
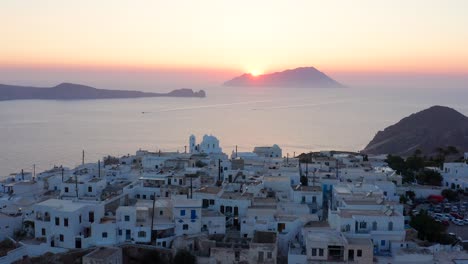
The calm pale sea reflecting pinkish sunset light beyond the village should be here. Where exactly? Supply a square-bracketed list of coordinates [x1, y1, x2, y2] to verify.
[0, 87, 468, 175]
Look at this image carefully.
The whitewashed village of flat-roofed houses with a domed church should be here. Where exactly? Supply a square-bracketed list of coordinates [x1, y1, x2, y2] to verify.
[0, 135, 468, 264]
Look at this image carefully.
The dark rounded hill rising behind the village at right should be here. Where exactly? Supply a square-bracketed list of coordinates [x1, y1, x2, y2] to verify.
[362, 106, 468, 156]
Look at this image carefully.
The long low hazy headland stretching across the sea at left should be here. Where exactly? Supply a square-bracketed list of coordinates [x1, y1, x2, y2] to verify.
[0, 83, 206, 101]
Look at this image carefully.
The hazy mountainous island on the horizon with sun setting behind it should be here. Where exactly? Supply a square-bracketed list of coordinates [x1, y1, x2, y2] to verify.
[224, 67, 344, 88]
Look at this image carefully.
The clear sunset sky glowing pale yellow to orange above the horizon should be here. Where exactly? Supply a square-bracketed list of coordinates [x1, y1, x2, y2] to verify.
[0, 0, 468, 89]
